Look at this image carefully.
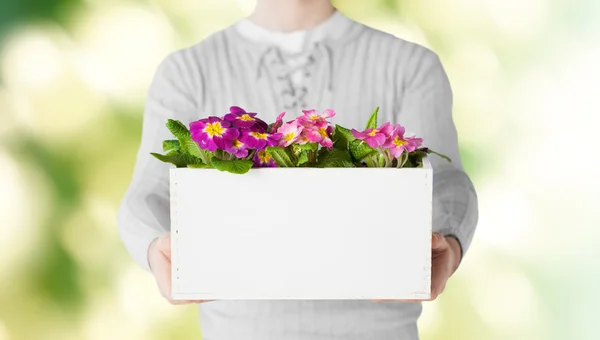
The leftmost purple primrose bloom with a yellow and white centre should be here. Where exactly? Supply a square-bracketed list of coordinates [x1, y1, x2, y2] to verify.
[190, 117, 240, 151]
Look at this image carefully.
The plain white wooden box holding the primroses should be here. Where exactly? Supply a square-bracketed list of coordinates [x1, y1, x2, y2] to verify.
[170, 159, 433, 300]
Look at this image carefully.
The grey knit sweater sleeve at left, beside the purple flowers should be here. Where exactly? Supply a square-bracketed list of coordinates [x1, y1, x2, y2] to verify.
[117, 52, 196, 271]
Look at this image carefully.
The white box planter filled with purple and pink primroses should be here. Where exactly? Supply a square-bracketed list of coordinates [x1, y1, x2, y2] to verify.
[153, 107, 450, 300]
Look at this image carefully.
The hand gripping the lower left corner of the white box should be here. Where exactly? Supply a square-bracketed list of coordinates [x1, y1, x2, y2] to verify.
[148, 233, 210, 305]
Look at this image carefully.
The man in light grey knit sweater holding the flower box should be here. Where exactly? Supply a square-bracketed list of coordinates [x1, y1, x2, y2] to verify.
[118, 0, 477, 340]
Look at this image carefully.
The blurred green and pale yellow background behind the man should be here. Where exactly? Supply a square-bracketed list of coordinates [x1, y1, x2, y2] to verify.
[0, 0, 600, 340]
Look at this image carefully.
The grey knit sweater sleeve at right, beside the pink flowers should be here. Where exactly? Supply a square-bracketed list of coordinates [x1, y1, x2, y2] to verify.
[400, 48, 478, 258]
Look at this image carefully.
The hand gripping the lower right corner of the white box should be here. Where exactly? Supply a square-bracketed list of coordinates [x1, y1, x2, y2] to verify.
[374, 233, 461, 302]
